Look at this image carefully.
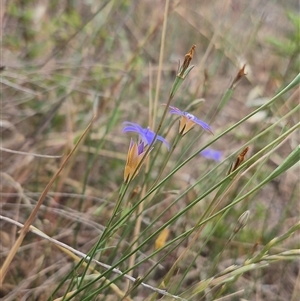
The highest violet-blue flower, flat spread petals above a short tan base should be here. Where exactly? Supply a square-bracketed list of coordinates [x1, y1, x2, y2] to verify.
[169, 106, 213, 135]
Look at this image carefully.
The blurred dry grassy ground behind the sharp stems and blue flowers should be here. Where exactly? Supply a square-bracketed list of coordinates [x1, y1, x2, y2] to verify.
[0, 0, 300, 301]
